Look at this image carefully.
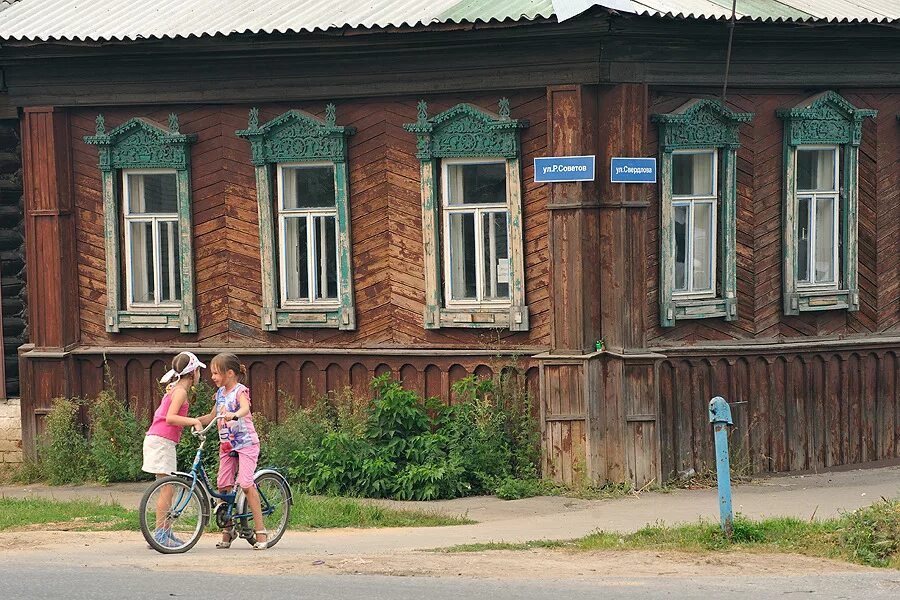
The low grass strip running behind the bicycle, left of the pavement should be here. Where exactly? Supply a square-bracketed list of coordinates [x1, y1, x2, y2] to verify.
[0, 495, 473, 531]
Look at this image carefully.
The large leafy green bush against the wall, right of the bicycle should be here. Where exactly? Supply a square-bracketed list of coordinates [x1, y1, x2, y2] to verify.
[280, 371, 539, 500]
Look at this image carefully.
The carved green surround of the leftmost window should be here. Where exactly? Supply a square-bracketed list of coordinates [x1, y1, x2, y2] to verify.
[84, 114, 197, 333]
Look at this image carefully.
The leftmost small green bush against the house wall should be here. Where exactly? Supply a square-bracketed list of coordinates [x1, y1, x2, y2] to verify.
[38, 398, 91, 485]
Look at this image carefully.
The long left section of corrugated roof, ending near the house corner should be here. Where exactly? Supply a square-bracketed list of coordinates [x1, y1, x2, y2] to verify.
[0, 0, 553, 40]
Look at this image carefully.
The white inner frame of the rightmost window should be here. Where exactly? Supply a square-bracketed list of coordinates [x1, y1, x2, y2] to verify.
[794, 144, 841, 290]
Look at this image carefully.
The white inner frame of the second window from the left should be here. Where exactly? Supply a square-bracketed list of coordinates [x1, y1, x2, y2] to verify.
[275, 161, 342, 309]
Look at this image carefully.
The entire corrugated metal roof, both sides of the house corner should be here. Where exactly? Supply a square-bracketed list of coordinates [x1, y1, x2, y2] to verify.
[0, 0, 900, 41]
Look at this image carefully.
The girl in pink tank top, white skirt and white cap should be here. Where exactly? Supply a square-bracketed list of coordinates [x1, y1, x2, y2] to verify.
[141, 352, 209, 546]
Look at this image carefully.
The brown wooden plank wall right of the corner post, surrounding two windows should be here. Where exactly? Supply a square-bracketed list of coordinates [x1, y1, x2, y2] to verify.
[646, 90, 900, 476]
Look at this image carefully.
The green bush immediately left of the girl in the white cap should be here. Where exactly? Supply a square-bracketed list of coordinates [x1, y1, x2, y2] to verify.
[88, 382, 150, 483]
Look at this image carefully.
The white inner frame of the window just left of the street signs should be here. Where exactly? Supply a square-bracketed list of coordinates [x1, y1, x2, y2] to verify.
[441, 157, 513, 309]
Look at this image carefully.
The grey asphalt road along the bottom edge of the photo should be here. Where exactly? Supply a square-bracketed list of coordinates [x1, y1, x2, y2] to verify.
[0, 561, 900, 600]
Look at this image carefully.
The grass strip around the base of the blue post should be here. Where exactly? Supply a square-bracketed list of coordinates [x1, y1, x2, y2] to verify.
[443, 500, 900, 569]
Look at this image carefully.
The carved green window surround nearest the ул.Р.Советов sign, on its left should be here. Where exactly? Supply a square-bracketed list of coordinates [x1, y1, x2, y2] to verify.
[403, 98, 529, 331]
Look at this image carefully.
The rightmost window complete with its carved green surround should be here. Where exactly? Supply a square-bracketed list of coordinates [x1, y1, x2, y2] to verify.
[778, 91, 876, 315]
